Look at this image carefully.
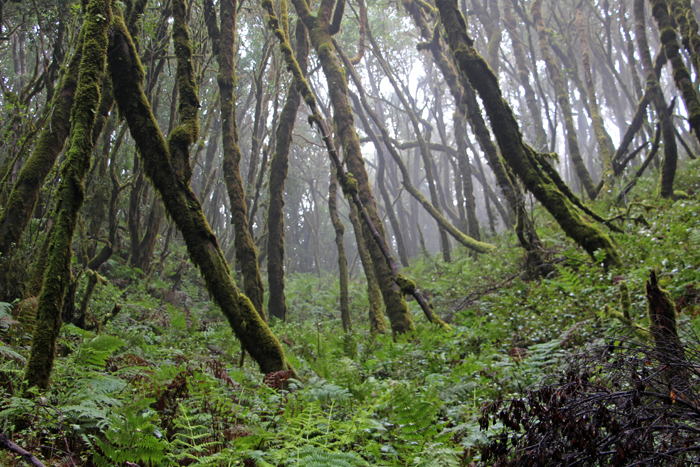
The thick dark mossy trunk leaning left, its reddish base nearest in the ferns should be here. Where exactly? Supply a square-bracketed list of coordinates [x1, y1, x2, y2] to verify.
[108, 5, 289, 373]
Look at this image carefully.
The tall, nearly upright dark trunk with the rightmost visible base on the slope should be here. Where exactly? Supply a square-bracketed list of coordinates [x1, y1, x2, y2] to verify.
[634, 0, 678, 198]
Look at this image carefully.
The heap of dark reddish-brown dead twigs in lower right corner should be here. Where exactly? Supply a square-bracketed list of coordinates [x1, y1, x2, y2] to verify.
[479, 332, 700, 467]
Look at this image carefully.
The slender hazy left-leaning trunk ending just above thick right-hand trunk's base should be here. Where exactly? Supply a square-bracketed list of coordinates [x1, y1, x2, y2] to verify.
[531, 0, 598, 199]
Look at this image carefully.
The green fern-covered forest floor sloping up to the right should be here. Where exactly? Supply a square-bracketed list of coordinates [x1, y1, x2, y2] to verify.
[0, 161, 700, 467]
